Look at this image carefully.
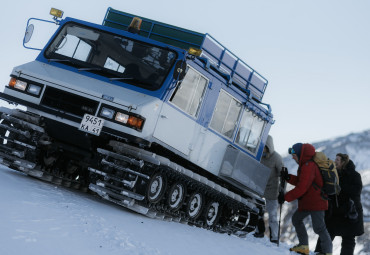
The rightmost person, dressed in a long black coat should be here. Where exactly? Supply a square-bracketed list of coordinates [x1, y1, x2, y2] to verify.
[315, 153, 364, 255]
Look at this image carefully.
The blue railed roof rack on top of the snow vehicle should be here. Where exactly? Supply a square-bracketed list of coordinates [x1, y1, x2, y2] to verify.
[103, 7, 268, 102]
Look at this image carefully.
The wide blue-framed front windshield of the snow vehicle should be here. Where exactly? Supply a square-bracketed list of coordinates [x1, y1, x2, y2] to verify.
[45, 23, 177, 90]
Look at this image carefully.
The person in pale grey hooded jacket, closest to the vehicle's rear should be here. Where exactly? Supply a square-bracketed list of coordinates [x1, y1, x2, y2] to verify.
[254, 135, 284, 243]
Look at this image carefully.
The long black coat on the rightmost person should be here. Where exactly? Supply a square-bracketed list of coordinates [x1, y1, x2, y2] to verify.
[325, 160, 364, 236]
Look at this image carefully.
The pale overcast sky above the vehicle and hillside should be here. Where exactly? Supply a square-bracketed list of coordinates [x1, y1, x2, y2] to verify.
[0, 0, 370, 154]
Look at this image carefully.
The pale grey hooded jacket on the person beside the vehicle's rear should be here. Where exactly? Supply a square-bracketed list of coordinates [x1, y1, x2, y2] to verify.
[261, 135, 283, 200]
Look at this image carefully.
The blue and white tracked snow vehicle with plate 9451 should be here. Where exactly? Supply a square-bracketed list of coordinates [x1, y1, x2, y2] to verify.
[0, 8, 274, 233]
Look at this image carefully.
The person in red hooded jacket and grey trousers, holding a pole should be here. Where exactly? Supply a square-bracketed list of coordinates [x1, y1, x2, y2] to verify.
[278, 143, 333, 255]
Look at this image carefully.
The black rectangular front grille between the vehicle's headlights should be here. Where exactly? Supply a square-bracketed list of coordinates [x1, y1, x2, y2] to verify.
[41, 87, 99, 117]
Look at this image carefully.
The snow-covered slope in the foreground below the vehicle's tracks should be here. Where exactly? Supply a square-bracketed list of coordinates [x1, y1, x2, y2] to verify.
[0, 166, 290, 255]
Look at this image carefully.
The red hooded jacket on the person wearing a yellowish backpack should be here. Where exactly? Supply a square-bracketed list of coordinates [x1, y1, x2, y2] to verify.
[285, 143, 328, 211]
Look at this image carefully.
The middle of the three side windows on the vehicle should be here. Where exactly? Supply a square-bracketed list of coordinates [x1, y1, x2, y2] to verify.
[210, 90, 242, 138]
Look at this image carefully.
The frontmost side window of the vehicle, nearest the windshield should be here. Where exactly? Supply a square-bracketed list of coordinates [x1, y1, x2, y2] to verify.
[170, 67, 208, 117]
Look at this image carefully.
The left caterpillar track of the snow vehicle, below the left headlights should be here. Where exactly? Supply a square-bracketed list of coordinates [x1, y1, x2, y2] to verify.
[0, 108, 88, 192]
